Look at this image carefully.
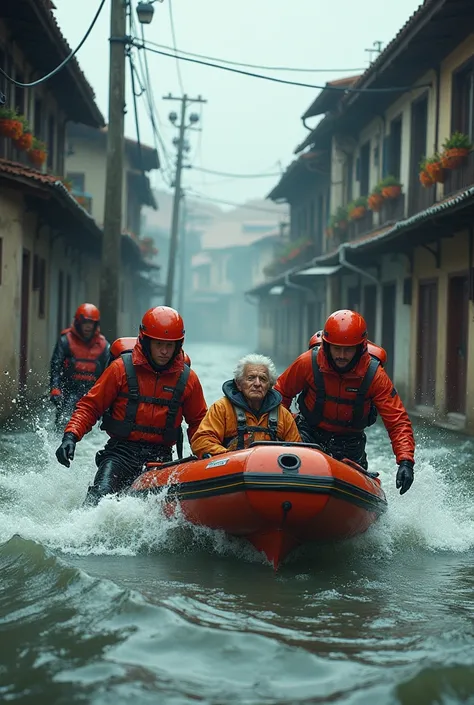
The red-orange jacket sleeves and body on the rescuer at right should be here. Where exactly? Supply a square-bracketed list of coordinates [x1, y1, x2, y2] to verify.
[275, 347, 415, 463]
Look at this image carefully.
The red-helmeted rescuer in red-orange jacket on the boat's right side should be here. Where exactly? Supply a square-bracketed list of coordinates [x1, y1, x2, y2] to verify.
[275, 310, 415, 494]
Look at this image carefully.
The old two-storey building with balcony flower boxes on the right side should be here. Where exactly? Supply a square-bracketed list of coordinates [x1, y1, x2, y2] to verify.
[246, 0, 474, 432]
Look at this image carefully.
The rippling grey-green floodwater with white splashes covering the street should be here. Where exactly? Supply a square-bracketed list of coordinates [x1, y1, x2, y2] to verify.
[0, 344, 474, 705]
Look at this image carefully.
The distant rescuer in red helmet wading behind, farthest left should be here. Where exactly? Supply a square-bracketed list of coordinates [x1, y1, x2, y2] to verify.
[50, 304, 110, 430]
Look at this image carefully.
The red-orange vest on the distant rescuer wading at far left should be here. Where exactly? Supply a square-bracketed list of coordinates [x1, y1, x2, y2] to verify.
[61, 330, 107, 387]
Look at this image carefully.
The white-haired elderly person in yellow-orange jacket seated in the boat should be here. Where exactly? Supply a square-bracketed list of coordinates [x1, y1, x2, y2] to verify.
[191, 355, 301, 458]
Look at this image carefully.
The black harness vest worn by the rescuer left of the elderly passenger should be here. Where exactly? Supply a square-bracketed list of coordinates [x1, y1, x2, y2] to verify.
[100, 350, 191, 444]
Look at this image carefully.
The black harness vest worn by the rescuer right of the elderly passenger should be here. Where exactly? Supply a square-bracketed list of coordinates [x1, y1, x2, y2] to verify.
[297, 348, 381, 431]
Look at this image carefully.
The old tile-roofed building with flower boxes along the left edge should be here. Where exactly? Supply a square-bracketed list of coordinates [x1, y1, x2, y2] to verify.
[0, 0, 156, 418]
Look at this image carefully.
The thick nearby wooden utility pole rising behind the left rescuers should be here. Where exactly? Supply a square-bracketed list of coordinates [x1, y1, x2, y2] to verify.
[99, 0, 127, 342]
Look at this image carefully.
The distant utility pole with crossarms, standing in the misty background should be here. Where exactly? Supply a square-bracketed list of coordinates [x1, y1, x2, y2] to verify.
[164, 94, 207, 306]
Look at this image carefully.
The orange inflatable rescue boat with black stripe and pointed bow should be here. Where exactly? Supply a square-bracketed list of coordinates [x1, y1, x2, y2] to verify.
[130, 441, 387, 570]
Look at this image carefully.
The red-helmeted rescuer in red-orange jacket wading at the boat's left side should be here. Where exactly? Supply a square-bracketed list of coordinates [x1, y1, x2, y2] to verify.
[56, 306, 207, 505]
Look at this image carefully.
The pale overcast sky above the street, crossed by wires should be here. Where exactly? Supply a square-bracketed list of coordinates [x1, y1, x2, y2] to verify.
[55, 0, 419, 209]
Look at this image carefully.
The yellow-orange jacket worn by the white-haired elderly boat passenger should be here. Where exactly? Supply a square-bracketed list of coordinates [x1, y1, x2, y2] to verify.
[191, 380, 301, 458]
